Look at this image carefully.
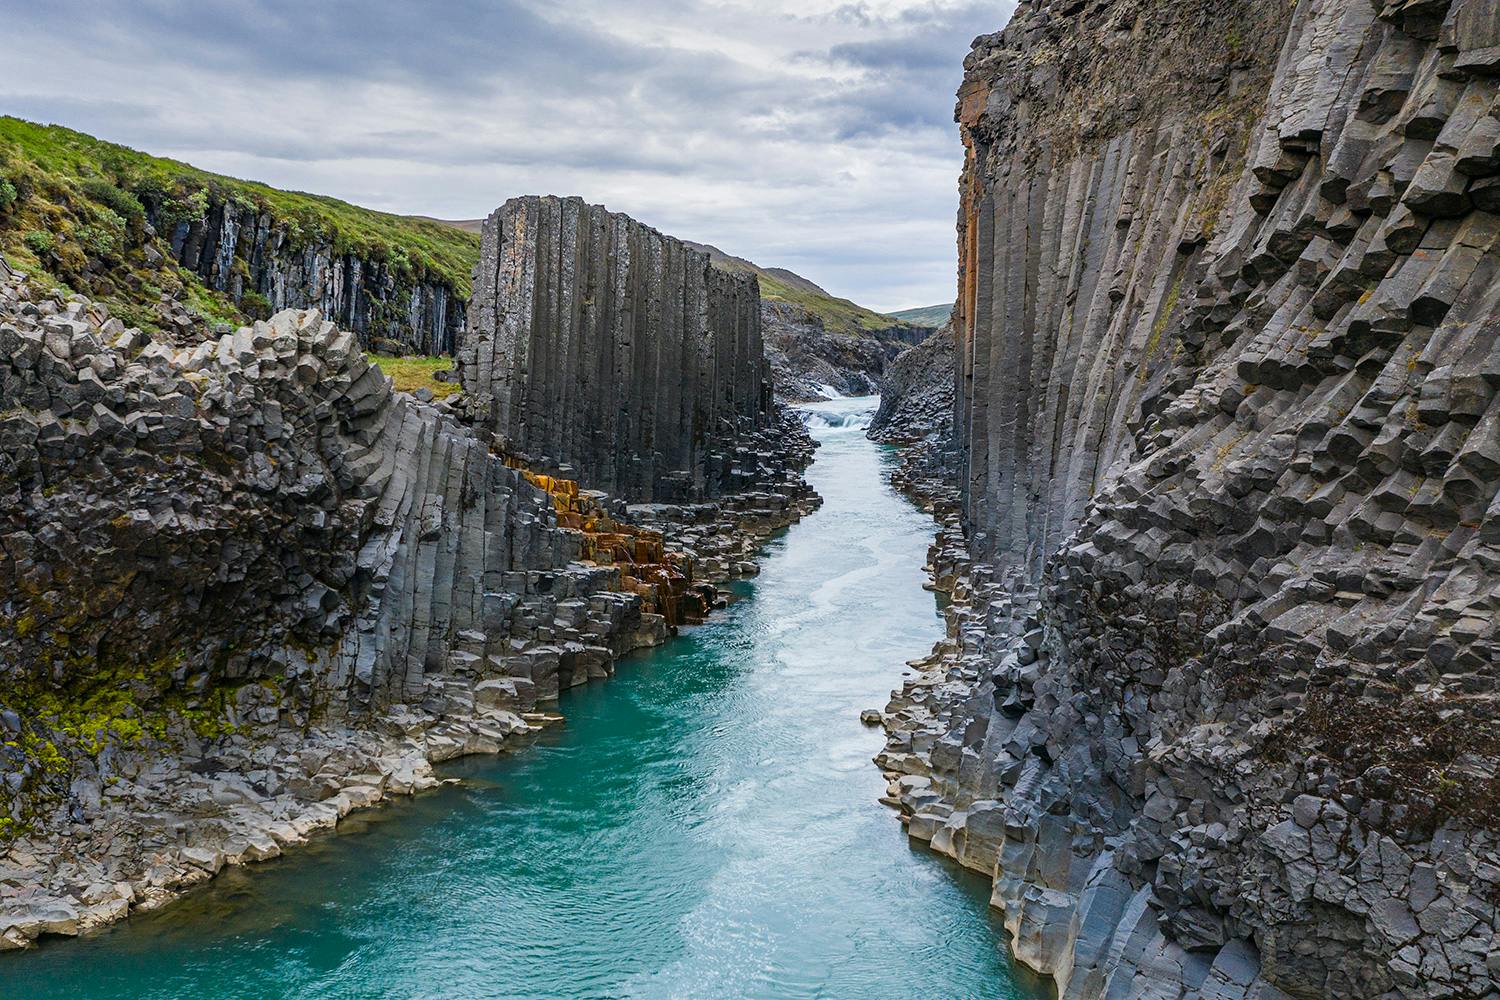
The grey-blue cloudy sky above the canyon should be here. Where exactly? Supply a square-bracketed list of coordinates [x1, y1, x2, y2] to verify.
[0, 0, 1014, 309]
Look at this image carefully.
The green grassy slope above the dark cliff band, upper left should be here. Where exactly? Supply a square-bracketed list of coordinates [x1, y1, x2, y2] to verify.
[0, 117, 479, 335]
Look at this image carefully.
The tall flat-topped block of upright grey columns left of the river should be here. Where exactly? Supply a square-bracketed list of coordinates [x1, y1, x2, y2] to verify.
[459, 196, 773, 501]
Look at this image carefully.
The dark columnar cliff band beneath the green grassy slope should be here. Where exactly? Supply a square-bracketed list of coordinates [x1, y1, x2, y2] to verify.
[156, 196, 467, 354]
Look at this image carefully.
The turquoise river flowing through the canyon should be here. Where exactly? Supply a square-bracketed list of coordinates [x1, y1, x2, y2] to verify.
[0, 399, 1047, 1000]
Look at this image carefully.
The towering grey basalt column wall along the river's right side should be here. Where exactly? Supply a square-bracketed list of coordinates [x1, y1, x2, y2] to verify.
[882, 0, 1500, 997]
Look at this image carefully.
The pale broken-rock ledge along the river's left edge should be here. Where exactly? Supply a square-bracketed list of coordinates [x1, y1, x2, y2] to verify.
[0, 418, 821, 951]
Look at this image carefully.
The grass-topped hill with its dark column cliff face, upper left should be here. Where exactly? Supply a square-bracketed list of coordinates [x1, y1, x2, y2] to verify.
[0, 115, 479, 355]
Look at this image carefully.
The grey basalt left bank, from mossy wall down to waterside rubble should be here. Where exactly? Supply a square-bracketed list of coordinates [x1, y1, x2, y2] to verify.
[0, 230, 818, 948]
